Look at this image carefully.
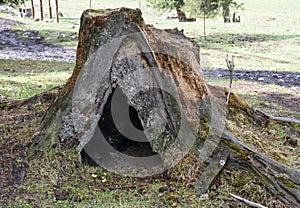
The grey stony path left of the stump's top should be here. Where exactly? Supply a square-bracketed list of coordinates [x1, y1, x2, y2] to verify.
[0, 18, 75, 62]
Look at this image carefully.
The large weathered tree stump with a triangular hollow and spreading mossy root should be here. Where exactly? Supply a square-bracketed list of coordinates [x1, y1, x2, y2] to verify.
[33, 8, 300, 207]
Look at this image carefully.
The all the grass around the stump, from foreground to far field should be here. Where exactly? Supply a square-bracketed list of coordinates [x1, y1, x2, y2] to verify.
[0, 0, 300, 207]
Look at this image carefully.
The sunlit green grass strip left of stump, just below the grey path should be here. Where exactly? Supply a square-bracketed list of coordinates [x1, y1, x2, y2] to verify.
[0, 60, 74, 101]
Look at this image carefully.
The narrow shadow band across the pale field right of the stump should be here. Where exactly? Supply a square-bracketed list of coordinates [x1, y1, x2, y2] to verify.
[197, 33, 300, 47]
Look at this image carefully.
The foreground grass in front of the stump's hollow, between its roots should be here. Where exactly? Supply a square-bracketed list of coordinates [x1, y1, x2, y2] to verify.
[11, 150, 288, 208]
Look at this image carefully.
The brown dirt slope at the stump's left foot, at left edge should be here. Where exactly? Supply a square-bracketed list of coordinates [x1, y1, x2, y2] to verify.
[0, 93, 53, 207]
